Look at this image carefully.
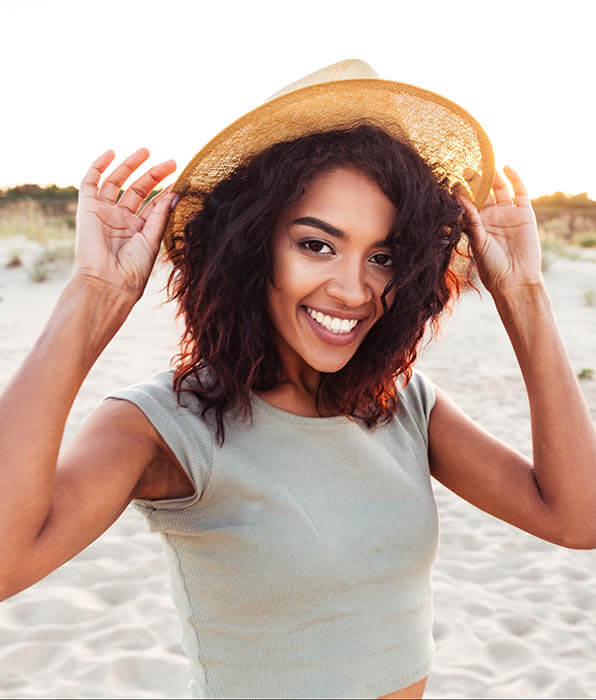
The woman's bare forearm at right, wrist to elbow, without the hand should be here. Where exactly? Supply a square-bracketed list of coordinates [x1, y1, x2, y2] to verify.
[495, 287, 596, 536]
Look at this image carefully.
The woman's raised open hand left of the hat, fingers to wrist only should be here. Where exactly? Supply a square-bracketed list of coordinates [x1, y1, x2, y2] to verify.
[74, 148, 176, 300]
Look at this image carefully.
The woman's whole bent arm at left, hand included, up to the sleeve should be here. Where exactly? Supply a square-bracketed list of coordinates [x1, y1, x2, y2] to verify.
[0, 149, 179, 597]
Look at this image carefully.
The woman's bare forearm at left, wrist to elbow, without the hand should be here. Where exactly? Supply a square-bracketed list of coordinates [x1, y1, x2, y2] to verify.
[0, 279, 134, 562]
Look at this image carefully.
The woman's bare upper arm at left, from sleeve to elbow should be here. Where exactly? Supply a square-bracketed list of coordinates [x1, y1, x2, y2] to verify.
[0, 399, 168, 599]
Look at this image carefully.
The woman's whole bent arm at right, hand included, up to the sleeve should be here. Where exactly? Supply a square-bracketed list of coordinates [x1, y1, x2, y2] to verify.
[429, 170, 596, 548]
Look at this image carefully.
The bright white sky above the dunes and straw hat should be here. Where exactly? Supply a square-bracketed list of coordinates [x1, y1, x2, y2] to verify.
[0, 0, 596, 199]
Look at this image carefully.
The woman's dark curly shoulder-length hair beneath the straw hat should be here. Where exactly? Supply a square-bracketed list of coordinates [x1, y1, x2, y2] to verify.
[168, 122, 473, 443]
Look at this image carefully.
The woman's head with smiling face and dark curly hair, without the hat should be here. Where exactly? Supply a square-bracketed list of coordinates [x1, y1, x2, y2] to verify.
[170, 120, 471, 439]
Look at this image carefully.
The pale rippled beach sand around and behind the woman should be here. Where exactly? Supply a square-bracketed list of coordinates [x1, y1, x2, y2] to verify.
[0, 253, 596, 698]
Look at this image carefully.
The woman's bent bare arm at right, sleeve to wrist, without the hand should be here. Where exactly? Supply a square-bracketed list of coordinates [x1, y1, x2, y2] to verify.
[429, 288, 596, 549]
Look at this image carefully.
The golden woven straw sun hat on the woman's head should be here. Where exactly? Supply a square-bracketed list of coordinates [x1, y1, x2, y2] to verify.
[164, 59, 494, 252]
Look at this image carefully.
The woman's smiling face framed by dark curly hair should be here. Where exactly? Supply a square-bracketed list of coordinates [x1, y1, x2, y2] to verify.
[267, 168, 396, 372]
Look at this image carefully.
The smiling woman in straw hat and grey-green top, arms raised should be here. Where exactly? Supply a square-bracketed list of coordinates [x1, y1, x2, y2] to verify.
[0, 62, 596, 698]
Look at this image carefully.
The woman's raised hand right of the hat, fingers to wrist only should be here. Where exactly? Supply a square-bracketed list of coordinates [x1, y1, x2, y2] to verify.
[459, 166, 544, 295]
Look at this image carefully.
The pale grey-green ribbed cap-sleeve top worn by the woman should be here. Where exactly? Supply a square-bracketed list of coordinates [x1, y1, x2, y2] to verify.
[106, 370, 439, 698]
